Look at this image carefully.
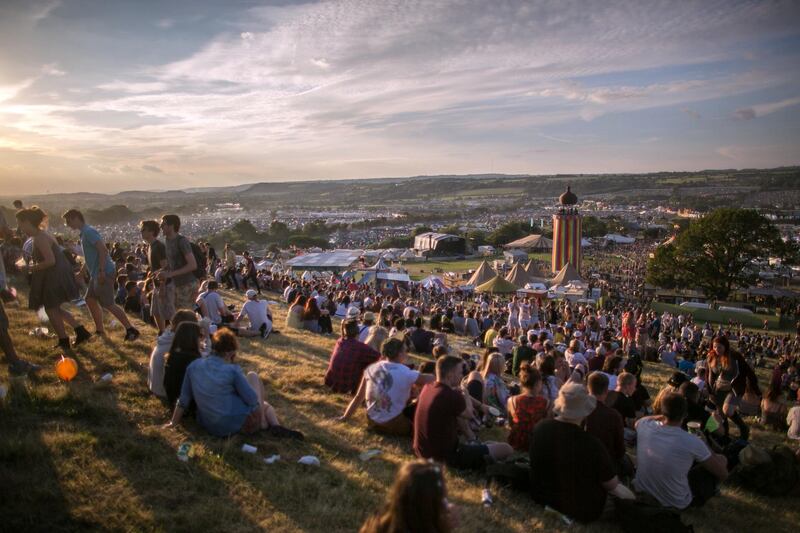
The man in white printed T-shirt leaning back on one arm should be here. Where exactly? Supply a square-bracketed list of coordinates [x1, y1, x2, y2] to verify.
[341, 339, 434, 436]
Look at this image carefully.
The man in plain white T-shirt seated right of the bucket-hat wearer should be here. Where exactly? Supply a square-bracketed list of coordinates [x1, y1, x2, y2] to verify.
[633, 393, 728, 510]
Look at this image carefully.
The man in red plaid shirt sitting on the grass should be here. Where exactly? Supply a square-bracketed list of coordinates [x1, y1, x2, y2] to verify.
[325, 320, 380, 394]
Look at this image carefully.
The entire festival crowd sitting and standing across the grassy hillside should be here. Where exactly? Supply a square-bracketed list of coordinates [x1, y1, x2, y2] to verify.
[0, 201, 800, 532]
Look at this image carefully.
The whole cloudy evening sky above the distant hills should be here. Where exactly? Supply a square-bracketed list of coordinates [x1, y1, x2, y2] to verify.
[0, 0, 800, 196]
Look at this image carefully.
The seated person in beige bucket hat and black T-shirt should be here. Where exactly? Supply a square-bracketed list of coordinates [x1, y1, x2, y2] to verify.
[530, 383, 634, 522]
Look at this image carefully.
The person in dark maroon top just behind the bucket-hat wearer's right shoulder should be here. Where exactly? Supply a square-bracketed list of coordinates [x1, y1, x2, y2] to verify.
[584, 371, 627, 474]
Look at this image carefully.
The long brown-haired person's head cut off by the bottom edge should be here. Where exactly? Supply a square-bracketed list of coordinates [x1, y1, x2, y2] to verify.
[359, 461, 457, 533]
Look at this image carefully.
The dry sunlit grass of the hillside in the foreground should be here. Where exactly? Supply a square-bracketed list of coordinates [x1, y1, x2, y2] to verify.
[0, 284, 800, 532]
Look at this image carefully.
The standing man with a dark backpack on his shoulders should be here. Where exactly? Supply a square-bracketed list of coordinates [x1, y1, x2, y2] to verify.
[158, 215, 197, 309]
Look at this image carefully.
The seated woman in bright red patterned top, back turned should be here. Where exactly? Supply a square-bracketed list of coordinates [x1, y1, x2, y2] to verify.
[507, 363, 547, 452]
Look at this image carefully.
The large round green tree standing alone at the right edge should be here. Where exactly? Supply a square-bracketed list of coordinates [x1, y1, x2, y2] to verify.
[647, 208, 792, 300]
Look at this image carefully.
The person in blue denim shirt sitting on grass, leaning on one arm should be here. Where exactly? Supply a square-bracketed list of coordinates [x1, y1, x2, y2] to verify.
[165, 329, 304, 440]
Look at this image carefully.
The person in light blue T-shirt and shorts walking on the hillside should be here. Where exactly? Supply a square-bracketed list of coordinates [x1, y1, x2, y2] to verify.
[62, 209, 139, 341]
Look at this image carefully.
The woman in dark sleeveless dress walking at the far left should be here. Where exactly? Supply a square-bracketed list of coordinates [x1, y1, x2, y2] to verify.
[16, 206, 92, 350]
